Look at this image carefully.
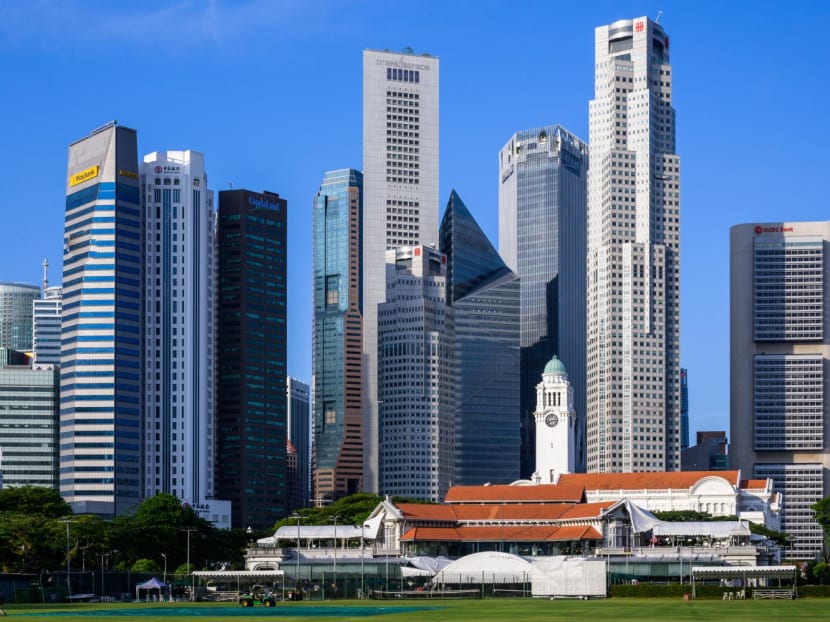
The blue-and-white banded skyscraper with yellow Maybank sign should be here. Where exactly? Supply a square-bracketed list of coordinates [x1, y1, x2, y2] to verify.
[60, 121, 142, 516]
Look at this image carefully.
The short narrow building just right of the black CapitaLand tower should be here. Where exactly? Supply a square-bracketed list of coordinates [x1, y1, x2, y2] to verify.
[285, 376, 311, 511]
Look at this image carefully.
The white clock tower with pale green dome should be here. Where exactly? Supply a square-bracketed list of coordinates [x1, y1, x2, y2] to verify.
[533, 356, 576, 484]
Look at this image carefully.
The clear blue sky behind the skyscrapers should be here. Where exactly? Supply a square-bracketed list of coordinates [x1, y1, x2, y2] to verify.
[0, 0, 830, 444]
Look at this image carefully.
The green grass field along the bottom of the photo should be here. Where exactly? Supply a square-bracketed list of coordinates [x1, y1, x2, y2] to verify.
[6, 598, 830, 622]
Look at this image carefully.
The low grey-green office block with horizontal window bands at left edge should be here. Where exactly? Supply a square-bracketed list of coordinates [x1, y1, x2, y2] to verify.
[0, 348, 59, 490]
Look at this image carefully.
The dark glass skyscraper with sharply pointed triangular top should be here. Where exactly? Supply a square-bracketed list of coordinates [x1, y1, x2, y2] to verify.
[440, 191, 521, 485]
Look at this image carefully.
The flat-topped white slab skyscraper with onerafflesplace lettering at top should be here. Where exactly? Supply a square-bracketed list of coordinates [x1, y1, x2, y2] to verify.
[362, 50, 438, 491]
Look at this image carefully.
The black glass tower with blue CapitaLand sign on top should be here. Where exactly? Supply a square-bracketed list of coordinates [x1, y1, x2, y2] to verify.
[216, 190, 288, 529]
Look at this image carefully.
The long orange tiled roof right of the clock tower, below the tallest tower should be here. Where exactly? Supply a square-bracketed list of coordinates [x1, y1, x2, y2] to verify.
[559, 471, 740, 490]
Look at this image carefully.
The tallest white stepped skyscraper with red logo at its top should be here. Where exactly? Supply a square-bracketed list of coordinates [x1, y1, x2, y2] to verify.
[584, 17, 680, 472]
